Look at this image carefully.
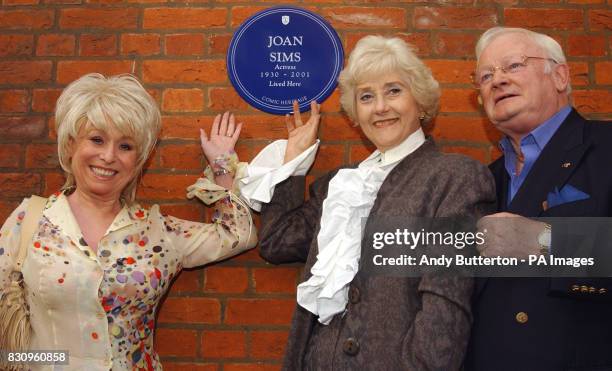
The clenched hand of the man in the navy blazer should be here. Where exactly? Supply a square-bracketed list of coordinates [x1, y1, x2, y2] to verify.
[477, 213, 546, 258]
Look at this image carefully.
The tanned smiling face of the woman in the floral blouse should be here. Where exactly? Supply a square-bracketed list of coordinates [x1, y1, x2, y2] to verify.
[71, 125, 138, 200]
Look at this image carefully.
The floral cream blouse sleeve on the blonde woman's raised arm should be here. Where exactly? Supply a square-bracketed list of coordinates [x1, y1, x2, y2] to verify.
[164, 154, 257, 268]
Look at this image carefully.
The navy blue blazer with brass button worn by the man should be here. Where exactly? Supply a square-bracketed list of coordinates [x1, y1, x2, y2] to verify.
[465, 110, 612, 371]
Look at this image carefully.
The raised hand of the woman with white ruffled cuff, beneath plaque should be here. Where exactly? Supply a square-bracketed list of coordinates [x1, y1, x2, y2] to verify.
[284, 100, 321, 164]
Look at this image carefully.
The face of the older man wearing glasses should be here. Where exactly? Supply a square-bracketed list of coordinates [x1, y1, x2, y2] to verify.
[478, 33, 569, 138]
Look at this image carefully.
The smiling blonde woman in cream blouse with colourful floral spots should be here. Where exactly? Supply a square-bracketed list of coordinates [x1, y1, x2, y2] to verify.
[0, 74, 256, 371]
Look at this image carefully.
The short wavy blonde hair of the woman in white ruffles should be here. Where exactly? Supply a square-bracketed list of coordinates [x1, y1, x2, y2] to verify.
[338, 35, 440, 124]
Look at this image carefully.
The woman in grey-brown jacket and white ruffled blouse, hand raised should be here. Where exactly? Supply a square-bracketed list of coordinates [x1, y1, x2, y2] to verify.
[241, 36, 495, 370]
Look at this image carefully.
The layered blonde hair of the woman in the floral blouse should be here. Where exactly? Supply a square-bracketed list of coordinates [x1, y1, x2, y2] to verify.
[55, 73, 161, 204]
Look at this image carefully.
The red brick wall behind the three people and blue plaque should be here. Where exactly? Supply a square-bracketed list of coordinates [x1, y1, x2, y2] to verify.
[0, 0, 612, 371]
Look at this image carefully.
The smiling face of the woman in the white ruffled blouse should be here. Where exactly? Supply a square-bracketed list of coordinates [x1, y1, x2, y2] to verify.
[355, 73, 421, 152]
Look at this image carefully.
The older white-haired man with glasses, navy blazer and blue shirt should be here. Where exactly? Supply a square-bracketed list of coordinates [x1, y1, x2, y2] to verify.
[465, 27, 612, 370]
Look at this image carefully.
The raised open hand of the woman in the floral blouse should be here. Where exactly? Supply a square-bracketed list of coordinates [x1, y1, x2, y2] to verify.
[200, 112, 242, 164]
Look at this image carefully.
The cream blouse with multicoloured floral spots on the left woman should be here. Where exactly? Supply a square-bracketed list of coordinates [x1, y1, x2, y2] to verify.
[0, 173, 257, 370]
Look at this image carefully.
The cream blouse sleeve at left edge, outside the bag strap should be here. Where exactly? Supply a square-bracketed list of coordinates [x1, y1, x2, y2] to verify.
[0, 199, 28, 296]
